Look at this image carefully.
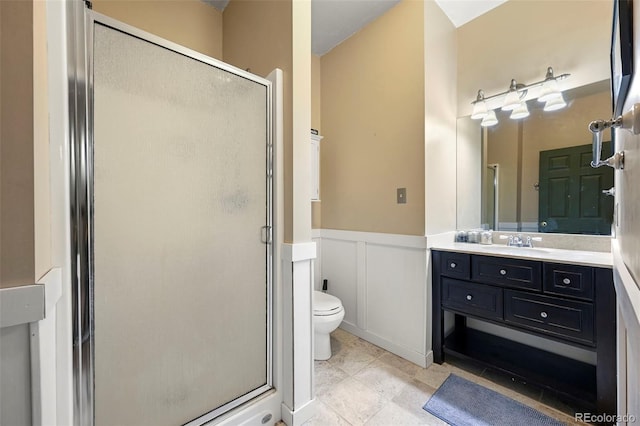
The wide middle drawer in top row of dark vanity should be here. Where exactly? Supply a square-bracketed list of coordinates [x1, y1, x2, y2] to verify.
[471, 256, 542, 291]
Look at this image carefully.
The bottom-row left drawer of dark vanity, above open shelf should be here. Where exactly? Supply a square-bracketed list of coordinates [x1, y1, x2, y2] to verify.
[442, 278, 503, 320]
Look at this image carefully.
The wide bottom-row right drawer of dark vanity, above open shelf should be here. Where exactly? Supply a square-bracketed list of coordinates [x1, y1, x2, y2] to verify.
[504, 290, 594, 346]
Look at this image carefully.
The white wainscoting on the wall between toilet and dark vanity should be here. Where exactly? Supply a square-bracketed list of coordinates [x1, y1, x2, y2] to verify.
[314, 229, 431, 367]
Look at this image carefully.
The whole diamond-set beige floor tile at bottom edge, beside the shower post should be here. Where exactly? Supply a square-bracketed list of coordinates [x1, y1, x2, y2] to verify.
[318, 378, 389, 426]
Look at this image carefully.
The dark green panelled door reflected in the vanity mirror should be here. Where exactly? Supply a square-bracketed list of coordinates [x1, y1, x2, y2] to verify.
[538, 142, 613, 235]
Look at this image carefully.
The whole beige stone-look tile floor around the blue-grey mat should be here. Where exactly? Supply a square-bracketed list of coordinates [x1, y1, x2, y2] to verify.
[304, 329, 581, 426]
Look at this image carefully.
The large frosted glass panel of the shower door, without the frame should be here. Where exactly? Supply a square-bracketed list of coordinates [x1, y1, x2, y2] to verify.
[93, 24, 268, 426]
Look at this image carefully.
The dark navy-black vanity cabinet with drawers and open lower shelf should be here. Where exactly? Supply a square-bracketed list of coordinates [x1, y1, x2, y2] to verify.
[431, 250, 616, 414]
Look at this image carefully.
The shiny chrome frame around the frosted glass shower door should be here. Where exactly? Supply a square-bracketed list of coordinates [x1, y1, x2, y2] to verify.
[67, 7, 275, 426]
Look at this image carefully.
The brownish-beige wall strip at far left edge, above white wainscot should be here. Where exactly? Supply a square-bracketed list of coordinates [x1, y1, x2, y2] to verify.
[0, 1, 36, 287]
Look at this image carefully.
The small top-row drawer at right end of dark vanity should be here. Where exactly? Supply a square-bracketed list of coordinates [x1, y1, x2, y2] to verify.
[543, 263, 594, 300]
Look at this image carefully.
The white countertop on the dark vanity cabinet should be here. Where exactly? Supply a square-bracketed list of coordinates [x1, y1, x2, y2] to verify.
[430, 242, 613, 268]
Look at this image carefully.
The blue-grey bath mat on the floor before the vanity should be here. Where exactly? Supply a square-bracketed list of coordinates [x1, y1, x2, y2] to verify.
[422, 374, 564, 426]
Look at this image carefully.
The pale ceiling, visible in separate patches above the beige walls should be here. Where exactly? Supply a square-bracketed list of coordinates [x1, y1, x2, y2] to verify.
[203, 0, 507, 55]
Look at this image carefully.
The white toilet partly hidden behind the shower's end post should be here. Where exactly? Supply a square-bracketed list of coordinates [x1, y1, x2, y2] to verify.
[313, 291, 344, 361]
